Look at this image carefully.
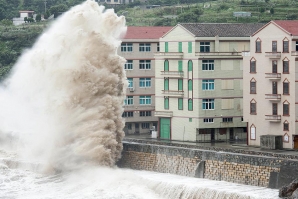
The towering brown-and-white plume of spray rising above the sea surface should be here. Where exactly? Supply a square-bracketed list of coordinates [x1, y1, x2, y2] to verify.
[0, 0, 127, 170]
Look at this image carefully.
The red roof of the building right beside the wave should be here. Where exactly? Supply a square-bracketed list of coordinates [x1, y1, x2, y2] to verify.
[124, 26, 173, 39]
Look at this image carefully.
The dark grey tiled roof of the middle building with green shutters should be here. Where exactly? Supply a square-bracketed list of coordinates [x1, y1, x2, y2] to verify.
[180, 23, 264, 37]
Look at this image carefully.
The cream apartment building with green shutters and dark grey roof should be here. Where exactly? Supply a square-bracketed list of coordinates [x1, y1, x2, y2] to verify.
[155, 23, 263, 141]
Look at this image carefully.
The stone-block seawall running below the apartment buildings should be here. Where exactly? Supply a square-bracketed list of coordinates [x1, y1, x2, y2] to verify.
[118, 139, 298, 188]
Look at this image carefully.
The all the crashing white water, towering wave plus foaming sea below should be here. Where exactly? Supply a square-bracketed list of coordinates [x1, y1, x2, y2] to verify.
[0, 0, 277, 199]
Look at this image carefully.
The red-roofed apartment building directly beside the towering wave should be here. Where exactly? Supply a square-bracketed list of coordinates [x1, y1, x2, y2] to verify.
[118, 27, 172, 134]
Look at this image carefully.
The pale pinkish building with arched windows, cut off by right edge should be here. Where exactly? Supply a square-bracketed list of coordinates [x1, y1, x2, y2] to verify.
[243, 21, 298, 149]
